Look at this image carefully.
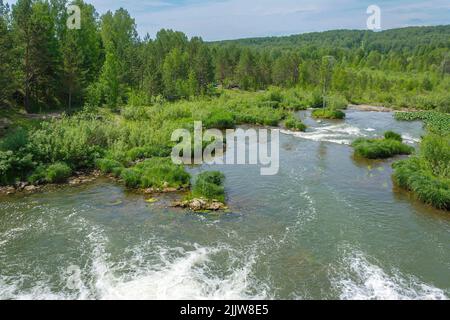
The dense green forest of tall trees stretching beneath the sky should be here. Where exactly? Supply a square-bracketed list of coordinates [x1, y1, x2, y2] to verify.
[0, 0, 450, 112]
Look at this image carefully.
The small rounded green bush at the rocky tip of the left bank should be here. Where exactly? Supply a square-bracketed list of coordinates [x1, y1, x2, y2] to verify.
[192, 171, 225, 202]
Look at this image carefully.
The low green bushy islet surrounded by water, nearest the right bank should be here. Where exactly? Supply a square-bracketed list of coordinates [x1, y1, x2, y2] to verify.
[352, 138, 414, 159]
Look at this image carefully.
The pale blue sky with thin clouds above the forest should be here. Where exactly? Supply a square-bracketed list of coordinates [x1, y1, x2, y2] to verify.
[7, 0, 450, 41]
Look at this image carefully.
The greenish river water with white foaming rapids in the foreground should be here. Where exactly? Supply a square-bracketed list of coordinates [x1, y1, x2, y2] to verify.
[0, 111, 450, 299]
